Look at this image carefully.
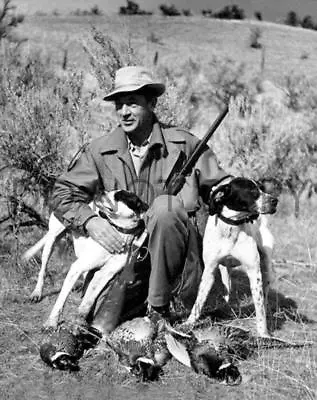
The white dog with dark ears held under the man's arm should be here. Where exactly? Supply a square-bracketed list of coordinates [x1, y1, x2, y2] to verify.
[24, 190, 148, 328]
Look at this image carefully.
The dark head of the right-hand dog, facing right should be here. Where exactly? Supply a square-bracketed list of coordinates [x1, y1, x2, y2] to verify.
[209, 178, 278, 216]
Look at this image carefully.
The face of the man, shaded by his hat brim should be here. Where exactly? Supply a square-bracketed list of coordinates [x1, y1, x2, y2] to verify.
[115, 93, 154, 136]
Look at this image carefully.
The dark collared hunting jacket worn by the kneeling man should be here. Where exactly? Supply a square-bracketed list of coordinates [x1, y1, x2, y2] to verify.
[52, 120, 227, 232]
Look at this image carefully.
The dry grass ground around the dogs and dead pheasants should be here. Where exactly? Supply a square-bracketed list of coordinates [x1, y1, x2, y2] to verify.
[0, 195, 317, 400]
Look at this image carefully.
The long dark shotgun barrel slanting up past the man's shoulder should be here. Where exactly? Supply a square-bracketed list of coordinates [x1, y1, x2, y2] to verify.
[165, 104, 229, 196]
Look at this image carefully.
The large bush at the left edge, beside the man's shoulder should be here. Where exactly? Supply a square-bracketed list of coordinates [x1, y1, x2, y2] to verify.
[0, 45, 89, 231]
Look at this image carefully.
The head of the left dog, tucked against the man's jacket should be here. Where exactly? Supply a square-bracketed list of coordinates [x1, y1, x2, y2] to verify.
[95, 190, 148, 220]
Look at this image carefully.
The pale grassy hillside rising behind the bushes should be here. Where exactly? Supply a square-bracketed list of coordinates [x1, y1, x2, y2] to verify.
[16, 15, 317, 83]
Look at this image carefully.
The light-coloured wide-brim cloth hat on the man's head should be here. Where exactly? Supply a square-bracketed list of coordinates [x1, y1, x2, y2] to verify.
[103, 66, 165, 101]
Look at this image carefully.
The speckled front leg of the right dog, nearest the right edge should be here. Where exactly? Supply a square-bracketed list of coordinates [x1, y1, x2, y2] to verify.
[232, 237, 270, 337]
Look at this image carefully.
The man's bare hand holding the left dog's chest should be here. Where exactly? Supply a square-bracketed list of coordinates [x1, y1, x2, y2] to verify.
[85, 216, 126, 254]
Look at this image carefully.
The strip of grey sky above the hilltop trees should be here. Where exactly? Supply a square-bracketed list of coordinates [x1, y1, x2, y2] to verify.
[12, 0, 317, 21]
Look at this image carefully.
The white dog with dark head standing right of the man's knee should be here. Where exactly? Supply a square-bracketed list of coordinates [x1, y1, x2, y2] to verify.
[186, 178, 280, 337]
